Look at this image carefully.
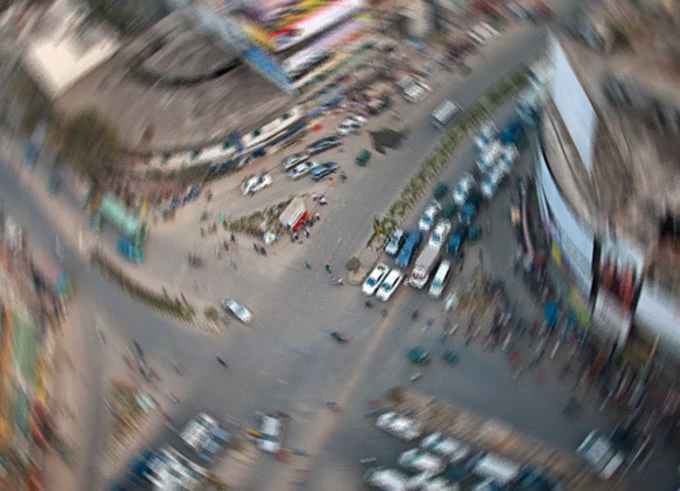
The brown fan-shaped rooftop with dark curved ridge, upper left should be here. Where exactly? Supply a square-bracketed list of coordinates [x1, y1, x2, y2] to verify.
[56, 14, 294, 154]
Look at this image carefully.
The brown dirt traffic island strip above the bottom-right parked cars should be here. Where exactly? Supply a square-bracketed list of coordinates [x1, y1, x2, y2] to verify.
[385, 387, 611, 491]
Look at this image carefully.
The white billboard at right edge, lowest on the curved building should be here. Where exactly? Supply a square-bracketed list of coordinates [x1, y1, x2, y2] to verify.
[635, 280, 680, 352]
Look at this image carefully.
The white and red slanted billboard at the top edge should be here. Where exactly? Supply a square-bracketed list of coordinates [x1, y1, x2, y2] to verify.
[269, 0, 365, 52]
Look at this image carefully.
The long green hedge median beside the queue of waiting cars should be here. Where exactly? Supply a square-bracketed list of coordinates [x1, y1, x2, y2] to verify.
[367, 67, 528, 247]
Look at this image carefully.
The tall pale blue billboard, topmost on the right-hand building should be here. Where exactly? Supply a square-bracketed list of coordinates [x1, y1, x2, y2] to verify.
[550, 37, 597, 177]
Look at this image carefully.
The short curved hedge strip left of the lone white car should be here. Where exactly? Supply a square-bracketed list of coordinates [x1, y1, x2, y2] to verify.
[90, 249, 194, 321]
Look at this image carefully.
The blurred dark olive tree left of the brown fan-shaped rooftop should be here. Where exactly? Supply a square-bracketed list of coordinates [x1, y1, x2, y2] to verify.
[56, 109, 119, 182]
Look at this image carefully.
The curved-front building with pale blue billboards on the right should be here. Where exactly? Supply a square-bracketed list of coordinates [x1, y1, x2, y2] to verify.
[535, 0, 680, 362]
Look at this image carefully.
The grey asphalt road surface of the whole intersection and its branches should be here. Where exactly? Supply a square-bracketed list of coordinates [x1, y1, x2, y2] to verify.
[7, 0, 672, 490]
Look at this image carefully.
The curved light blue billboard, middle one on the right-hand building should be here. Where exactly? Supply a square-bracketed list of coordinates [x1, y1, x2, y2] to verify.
[536, 140, 595, 299]
